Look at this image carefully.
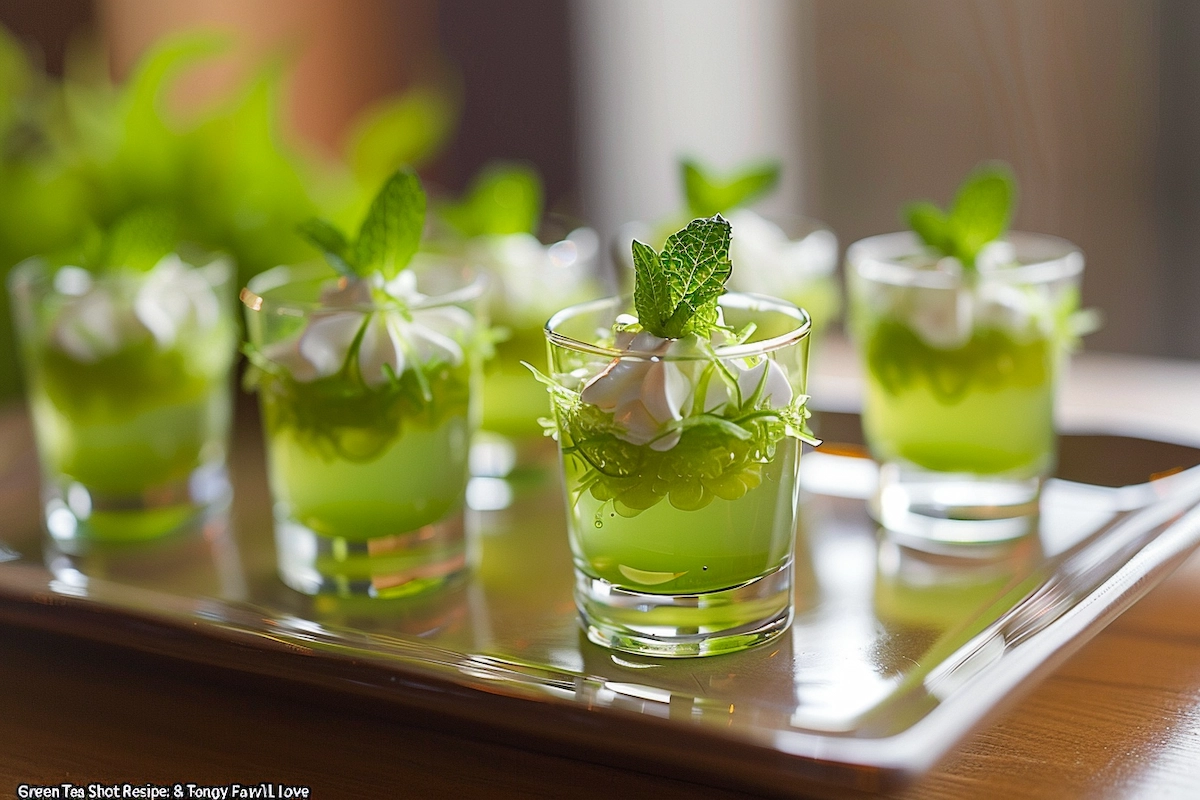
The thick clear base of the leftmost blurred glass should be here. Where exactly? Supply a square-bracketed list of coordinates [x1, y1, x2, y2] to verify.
[42, 461, 233, 553]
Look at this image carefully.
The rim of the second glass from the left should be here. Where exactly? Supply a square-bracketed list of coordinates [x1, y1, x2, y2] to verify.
[238, 253, 488, 317]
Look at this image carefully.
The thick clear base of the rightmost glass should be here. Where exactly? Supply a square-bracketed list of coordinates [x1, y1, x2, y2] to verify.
[870, 463, 1042, 546]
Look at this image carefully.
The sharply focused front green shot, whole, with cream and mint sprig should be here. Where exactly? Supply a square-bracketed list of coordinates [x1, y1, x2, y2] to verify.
[540, 215, 815, 657]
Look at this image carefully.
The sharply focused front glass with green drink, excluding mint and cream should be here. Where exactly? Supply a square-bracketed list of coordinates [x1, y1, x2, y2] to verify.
[546, 294, 810, 656]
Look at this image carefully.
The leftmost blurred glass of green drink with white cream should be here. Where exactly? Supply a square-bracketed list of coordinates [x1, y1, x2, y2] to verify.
[10, 253, 238, 544]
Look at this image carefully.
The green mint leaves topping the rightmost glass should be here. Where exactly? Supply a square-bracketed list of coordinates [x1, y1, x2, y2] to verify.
[904, 163, 1016, 270]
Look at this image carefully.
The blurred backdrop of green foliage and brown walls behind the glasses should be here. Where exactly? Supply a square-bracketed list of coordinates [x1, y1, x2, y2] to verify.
[0, 0, 1200, 395]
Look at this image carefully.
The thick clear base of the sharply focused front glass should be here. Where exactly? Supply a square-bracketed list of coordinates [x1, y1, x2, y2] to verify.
[575, 563, 792, 658]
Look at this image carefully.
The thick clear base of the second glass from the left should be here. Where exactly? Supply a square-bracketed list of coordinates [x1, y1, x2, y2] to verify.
[275, 507, 475, 597]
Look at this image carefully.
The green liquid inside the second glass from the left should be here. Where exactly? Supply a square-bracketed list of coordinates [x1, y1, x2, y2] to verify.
[259, 365, 470, 541]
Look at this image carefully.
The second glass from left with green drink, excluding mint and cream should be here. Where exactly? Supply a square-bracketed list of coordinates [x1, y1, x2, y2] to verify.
[241, 262, 486, 597]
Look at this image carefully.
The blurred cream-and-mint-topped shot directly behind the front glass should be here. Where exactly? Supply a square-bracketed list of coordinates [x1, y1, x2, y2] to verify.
[622, 158, 841, 338]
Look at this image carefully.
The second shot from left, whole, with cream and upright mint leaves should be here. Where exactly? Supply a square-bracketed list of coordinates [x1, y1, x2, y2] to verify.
[241, 170, 487, 597]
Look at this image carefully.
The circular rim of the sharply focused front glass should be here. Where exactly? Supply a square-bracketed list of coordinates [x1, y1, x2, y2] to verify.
[542, 291, 812, 361]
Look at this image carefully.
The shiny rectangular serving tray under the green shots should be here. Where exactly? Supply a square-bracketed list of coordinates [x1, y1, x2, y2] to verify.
[0, 413, 1200, 796]
